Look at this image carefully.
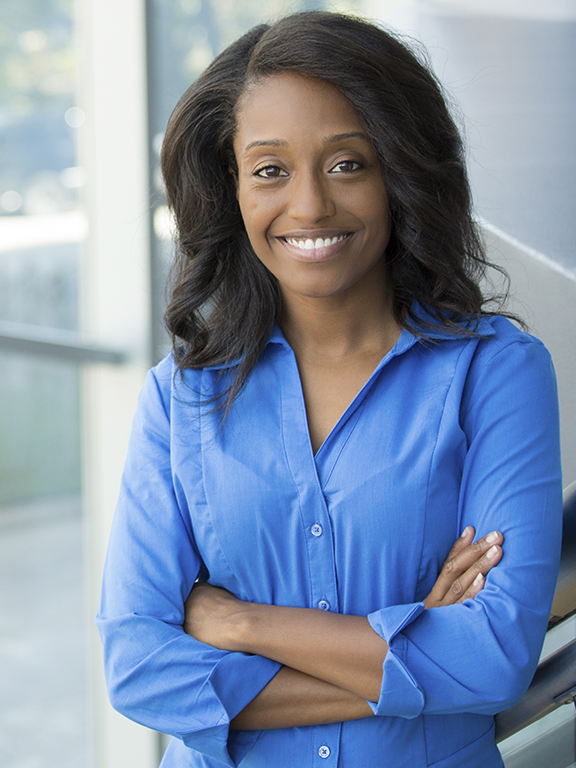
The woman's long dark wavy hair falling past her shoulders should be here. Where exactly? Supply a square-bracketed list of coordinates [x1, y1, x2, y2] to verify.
[162, 11, 510, 412]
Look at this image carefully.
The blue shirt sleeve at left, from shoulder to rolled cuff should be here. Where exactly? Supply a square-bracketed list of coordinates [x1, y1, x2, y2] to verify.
[96, 363, 280, 766]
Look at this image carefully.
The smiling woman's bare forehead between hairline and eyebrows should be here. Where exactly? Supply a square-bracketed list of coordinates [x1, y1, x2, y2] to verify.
[235, 72, 364, 151]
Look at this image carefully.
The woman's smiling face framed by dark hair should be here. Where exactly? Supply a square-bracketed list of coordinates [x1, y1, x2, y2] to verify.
[234, 72, 390, 299]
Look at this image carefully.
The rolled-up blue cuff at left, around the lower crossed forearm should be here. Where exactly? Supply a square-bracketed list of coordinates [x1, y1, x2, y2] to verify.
[179, 653, 282, 768]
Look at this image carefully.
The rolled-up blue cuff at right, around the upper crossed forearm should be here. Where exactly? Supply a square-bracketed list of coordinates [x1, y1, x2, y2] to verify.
[368, 603, 425, 719]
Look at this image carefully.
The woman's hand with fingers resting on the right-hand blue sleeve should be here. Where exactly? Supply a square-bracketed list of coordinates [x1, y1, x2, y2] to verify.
[424, 525, 504, 608]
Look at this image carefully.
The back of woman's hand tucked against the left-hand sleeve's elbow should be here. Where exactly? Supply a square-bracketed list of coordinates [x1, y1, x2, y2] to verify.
[184, 582, 250, 651]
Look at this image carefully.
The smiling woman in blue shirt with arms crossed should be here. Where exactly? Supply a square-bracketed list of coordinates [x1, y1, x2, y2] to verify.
[98, 12, 561, 768]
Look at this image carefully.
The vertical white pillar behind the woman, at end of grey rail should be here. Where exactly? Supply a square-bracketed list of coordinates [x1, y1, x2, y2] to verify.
[77, 0, 158, 768]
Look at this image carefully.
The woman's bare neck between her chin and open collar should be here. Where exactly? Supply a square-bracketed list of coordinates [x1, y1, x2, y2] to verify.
[280, 264, 401, 362]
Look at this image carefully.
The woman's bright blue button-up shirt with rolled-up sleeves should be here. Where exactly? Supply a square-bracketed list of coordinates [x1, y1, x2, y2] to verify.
[98, 317, 561, 768]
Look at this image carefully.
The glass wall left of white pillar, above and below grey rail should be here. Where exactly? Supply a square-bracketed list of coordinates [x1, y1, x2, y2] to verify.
[0, 0, 88, 768]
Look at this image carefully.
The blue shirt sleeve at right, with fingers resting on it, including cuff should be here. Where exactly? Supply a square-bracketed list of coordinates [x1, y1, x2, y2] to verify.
[368, 336, 562, 718]
